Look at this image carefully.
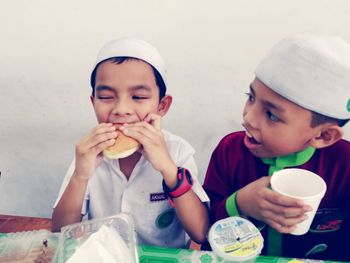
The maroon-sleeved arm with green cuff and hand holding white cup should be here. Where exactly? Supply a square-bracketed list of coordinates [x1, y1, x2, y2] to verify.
[204, 143, 309, 233]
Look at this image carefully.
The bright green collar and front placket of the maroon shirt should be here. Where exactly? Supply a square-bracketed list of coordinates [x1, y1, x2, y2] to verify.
[261, 147, 315, 256]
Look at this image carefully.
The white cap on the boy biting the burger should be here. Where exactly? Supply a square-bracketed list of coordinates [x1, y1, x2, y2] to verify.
[91, 38, 166, 88]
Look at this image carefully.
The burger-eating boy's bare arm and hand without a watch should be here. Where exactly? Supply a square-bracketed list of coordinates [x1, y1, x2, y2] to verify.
[52, 123, 117, 231]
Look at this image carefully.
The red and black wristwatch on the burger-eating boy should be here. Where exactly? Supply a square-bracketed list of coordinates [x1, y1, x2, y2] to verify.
[163, 167, 193, 207]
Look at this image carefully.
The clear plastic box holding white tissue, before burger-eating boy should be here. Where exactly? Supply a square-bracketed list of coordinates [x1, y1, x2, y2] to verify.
[55, 213, 139, 263]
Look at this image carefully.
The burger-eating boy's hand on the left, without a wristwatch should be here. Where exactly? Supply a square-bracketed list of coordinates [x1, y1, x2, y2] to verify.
[74, 123, 118, 179]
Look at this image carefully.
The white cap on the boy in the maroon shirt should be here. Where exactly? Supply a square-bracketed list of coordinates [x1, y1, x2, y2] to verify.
[255, 35, 350, 119]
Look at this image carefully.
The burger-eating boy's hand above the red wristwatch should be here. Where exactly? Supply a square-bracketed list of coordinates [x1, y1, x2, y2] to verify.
[120, 113, 176, 174]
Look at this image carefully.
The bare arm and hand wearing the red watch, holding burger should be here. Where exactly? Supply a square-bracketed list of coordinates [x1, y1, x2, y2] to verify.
[121, 114, 209, 243]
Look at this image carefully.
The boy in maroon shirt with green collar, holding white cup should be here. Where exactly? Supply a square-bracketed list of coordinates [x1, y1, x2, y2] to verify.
[204, 36, 350, 261]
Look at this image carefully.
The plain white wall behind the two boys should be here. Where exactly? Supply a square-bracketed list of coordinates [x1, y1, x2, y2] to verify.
[0, 0, 350, 217]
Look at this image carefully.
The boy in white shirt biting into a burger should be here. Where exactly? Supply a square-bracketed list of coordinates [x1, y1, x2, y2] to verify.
[52, 38, 209, 250]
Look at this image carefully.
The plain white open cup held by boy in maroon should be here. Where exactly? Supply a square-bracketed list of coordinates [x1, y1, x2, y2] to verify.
[270, 168, 327, 235]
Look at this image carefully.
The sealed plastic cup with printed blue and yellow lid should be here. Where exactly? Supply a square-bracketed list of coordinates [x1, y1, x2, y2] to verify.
[208, 216, 264, 263]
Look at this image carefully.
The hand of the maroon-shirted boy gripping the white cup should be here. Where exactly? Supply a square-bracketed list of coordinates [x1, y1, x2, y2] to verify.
[236, 176, 311, 233]
